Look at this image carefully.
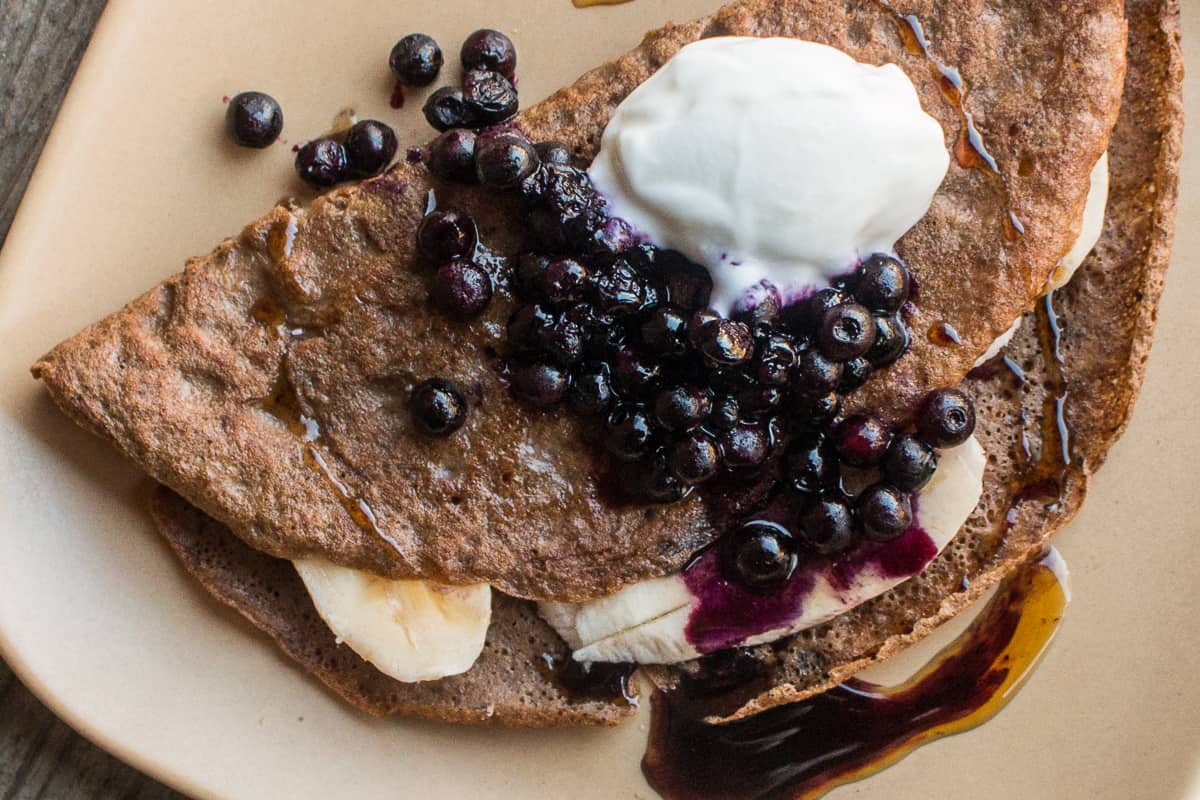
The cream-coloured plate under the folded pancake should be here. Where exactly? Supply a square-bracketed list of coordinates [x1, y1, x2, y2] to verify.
[0, 0, 1200, 800]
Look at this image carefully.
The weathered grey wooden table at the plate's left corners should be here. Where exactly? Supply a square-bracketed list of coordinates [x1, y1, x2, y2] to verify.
[0, 0, 181, 800]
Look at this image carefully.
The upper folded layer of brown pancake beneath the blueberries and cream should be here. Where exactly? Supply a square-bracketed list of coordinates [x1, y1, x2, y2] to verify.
[34, 0, 1126, 600]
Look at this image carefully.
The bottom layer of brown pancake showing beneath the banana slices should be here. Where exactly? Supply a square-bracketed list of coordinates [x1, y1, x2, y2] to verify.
[126, 0, 1182, 724]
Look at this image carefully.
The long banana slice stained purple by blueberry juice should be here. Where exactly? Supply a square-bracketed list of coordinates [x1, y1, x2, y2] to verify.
[539, 437, 988, 663]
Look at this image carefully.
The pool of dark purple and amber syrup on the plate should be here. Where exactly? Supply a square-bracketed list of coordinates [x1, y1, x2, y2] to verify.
[642, 549, 1070, 800]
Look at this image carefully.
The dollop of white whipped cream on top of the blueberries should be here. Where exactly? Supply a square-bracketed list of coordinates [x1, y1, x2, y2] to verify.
[589, 37, 949, 313]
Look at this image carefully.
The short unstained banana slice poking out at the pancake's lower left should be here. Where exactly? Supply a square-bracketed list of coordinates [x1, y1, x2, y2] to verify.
[293, 558, 492, 682]
